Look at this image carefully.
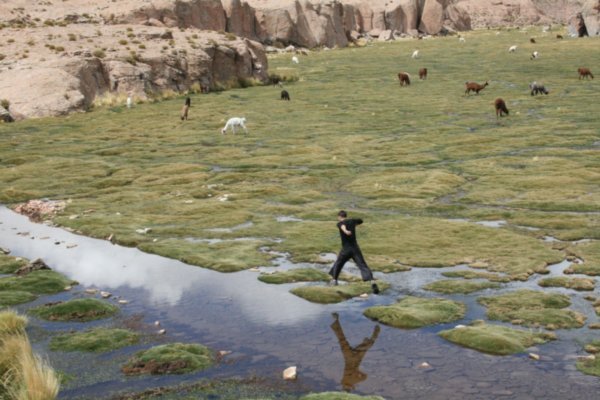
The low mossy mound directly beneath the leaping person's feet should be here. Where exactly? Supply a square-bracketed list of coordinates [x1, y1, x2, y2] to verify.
[290, 281, 390, 304]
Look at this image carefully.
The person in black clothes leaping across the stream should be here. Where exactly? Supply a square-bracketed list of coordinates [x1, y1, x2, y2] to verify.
[329, 210, 379, 294]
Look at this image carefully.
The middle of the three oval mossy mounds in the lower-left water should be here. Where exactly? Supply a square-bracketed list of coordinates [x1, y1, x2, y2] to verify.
[50, 328, 139, 353]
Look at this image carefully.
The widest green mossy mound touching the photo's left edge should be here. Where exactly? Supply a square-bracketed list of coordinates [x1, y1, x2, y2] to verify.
[0, 270, 74, 294]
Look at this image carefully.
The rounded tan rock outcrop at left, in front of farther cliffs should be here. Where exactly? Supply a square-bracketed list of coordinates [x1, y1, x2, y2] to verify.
[0, 24, 268, 118]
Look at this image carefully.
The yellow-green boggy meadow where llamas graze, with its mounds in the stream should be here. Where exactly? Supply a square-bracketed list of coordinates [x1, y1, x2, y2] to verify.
[0, 28, 600, 399]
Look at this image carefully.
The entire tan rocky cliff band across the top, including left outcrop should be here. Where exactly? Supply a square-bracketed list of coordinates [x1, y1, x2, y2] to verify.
[0, 0, 600, 119]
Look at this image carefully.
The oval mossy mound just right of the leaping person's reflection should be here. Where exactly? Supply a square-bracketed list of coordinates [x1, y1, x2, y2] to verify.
[364, 296, 466, 329]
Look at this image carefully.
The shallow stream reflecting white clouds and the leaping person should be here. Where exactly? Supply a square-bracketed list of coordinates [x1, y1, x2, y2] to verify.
[0, 208, 600, 400]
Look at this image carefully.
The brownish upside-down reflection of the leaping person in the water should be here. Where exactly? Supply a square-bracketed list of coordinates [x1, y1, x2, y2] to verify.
[331, 313, 381, 392]
